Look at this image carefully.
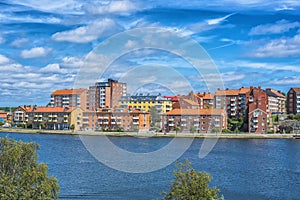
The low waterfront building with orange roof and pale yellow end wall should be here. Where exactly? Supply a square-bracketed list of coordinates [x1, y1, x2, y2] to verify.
[25, 107, 83, 130]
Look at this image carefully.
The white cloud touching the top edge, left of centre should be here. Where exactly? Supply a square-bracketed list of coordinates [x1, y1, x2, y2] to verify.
[84, 0, 138, 14]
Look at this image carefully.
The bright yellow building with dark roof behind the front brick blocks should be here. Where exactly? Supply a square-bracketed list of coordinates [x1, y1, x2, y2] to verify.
[119, 94, 172, 114]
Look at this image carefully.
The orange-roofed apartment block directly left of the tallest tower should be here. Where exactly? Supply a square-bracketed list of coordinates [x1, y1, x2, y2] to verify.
[50, 89, 87, 110]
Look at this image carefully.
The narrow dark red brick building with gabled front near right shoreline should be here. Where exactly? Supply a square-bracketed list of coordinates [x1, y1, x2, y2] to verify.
[246, 86, 269, 133]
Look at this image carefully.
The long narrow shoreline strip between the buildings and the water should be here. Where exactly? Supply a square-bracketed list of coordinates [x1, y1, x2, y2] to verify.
[0, 128, 295, 139]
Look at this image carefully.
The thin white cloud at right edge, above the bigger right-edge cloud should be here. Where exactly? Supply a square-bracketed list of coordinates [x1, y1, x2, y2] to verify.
[249, 19, 300, 35]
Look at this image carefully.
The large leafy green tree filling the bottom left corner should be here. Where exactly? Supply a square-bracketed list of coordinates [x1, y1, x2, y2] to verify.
[0, 138, 59, 200]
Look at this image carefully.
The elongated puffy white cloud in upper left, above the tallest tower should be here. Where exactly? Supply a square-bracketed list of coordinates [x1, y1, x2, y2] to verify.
[52, 18, 120, 43]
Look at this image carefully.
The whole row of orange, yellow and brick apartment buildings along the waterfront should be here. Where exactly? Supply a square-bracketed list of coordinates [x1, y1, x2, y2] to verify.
[9, 79, 300, 133]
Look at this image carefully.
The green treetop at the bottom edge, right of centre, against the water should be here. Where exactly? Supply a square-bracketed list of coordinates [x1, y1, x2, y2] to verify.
[164, 159, 224, 200]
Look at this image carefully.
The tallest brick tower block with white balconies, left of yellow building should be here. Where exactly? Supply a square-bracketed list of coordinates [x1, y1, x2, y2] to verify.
[87, 79, 127, 110]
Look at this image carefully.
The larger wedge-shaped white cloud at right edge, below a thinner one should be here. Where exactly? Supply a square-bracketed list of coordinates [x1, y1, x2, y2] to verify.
[249, 33, 300, 58]
